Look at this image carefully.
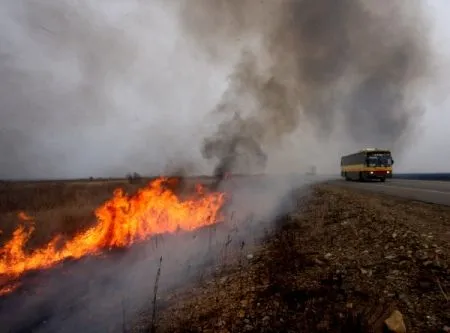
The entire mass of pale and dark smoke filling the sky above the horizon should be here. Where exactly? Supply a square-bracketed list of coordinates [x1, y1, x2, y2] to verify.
[0, 0, 436, 178]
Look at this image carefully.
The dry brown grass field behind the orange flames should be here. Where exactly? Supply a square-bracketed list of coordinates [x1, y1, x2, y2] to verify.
[0, 180, 142, 248]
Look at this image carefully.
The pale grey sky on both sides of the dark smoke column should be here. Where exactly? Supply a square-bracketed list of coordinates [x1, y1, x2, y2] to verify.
[0, 0, 450, 179]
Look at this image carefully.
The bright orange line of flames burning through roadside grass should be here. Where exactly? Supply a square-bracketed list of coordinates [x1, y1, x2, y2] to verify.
[0, 178, 225, 294]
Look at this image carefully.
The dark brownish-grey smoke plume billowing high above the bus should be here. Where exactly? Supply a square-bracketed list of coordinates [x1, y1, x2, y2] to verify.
[181, 0, 430, 175]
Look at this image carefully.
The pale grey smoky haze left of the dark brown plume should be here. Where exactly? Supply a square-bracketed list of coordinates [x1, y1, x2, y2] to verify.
[0, 0, 232, 179]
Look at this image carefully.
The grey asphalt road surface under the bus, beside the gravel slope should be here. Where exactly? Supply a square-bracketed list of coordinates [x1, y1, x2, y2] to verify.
[331, 179, 450, 206]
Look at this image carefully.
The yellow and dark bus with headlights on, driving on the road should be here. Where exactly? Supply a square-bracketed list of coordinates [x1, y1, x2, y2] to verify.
[341, 148, 394, 182]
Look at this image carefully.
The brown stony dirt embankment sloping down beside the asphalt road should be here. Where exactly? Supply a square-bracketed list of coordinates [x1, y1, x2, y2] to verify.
[145, 185, 450, 332]
